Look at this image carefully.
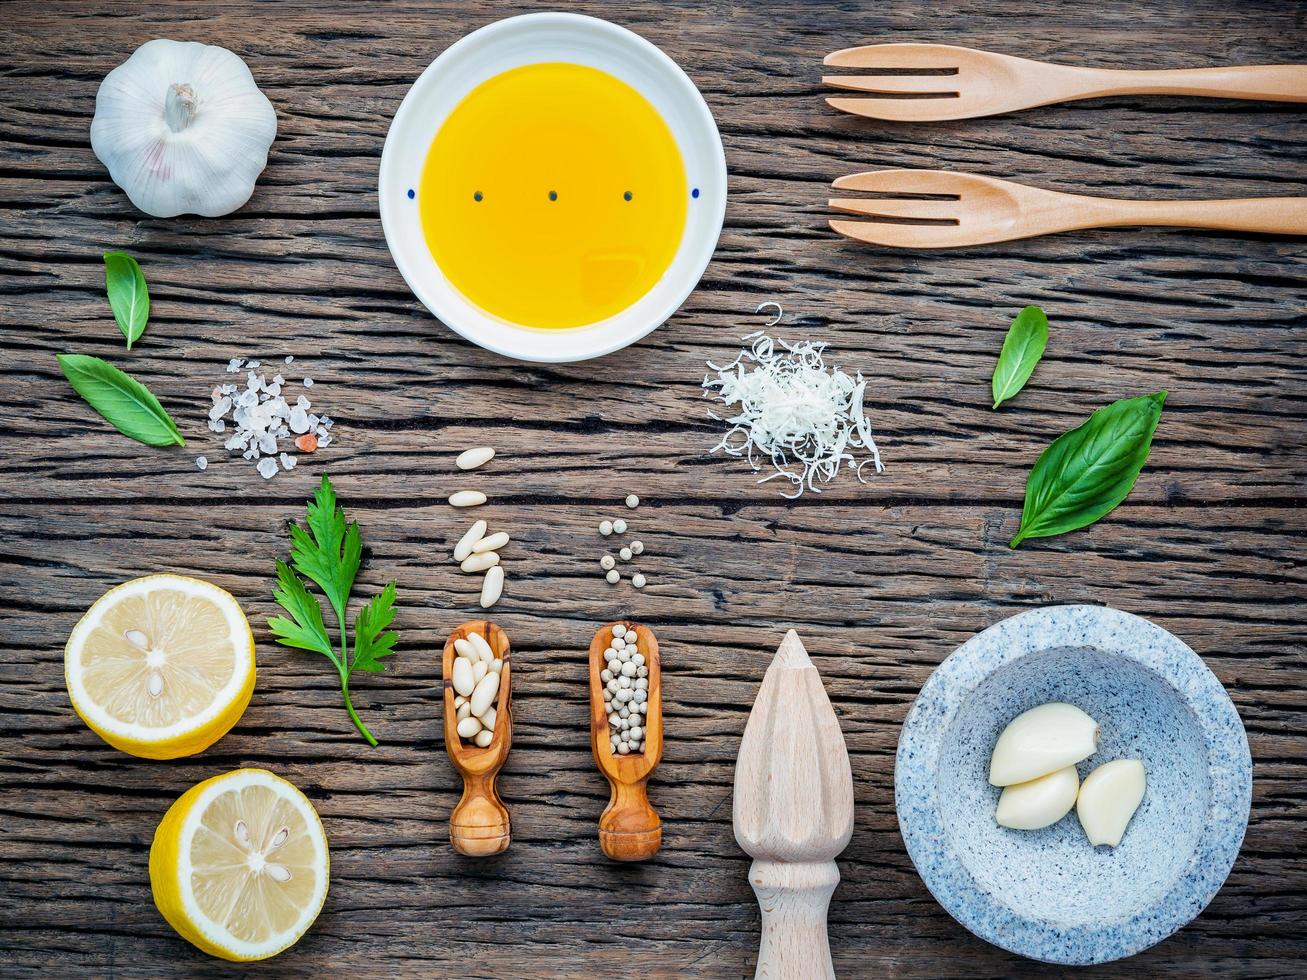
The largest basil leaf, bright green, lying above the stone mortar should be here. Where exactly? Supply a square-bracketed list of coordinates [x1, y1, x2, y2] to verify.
[1008, 391, 1166, 547]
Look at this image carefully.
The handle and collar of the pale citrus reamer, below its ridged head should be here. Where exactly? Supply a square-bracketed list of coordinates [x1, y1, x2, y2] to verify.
[749, 860, 839, 980]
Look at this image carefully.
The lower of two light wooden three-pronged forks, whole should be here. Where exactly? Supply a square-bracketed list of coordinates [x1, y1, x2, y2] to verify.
[830, 170, 1307, 248]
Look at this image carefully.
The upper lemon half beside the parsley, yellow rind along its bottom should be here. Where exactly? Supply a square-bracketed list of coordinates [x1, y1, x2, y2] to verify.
[64, 575, 255, 759]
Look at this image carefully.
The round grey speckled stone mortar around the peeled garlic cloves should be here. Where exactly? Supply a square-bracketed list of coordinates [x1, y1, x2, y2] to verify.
[894, 606, 1252, 964]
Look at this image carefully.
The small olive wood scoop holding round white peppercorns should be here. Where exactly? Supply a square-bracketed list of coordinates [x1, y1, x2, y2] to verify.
[589, 622, 663, 861]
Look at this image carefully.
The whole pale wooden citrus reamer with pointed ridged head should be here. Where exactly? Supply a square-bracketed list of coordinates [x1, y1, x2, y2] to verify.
[733, 630, 853, 980]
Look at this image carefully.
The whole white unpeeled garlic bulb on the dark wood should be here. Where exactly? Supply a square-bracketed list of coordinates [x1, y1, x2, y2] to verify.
[90, 39, 277, 218]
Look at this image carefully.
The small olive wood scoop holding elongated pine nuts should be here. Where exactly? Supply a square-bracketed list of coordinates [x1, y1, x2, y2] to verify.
[442, 619, 512, 857]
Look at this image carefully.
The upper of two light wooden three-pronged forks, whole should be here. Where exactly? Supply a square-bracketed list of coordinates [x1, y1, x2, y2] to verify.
[822, 44, 1307, 123]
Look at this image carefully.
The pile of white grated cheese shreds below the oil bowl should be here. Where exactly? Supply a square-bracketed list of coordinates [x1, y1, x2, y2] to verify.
[703, 331, 885, 500]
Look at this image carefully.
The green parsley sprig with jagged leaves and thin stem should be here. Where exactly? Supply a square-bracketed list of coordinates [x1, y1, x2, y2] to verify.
[268, 473, 399, 745]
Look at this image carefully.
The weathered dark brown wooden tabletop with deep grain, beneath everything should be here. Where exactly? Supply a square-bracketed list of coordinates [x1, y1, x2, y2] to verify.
[0, 0, 1307, 977]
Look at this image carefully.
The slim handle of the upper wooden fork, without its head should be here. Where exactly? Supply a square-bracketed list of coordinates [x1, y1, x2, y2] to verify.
[1060, 64, 1307, 102]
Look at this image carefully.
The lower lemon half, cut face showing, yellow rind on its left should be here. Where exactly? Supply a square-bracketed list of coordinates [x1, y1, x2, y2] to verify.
[150, 770, 331, 962]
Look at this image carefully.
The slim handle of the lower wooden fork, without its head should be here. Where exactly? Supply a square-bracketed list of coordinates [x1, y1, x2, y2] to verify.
[1065, 197, 1307, 235]
